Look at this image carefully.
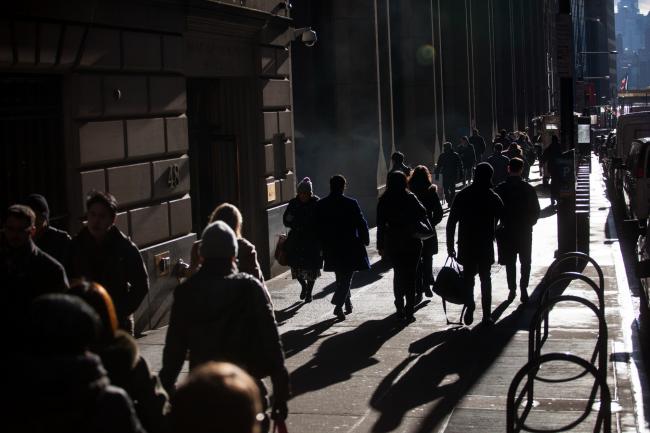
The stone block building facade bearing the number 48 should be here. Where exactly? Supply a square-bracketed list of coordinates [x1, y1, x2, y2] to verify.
[0, 0, 295, 330]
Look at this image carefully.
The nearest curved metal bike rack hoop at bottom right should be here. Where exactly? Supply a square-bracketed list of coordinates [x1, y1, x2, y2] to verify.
[506, 353, 612, 433]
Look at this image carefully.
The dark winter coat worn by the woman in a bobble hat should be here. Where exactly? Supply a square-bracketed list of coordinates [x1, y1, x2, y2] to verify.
[282, 196, 323, 270]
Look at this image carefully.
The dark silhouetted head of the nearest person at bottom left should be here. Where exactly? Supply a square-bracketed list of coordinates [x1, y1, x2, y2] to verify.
[27, 293, 100, 356]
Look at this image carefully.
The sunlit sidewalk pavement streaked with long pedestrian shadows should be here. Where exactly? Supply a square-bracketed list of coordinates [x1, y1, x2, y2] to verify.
[138, 159, 648, 433]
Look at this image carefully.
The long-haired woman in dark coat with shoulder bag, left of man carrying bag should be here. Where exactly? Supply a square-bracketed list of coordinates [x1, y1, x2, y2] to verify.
[377, 172, 431, 321]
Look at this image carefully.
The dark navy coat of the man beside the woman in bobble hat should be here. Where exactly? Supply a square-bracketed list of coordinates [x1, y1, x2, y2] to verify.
[316, 193, 370, 272]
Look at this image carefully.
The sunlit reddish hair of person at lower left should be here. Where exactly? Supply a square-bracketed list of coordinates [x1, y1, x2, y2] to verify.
[67, 280, 117, 343]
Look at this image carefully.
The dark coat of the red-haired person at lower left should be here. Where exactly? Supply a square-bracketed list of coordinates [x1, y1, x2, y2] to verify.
[94, 331, 170, 433]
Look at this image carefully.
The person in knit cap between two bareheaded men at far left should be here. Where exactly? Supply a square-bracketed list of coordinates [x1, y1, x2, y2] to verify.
[23, 194, 72, 265]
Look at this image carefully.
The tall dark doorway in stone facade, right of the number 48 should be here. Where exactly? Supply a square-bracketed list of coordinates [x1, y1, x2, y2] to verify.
[187, 79, 240, 233]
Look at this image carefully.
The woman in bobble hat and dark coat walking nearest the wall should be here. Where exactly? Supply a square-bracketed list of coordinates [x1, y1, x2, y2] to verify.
[282, 177, 323, 302]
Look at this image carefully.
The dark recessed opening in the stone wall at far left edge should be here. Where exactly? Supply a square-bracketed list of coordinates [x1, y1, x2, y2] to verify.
[0, 74, 68, 229]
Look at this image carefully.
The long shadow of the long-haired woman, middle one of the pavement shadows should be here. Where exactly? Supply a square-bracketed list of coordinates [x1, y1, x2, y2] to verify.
[291, 316, 404, 397]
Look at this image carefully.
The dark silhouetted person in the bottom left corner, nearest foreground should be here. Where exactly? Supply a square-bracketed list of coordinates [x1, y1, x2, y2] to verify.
[9, 294, 145, 433]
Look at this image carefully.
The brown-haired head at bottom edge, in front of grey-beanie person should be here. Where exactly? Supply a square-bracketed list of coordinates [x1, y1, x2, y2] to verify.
[169, 362, 264, 433]
